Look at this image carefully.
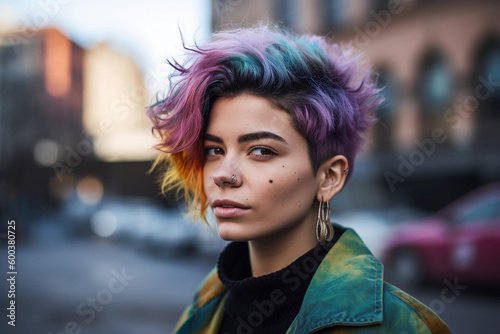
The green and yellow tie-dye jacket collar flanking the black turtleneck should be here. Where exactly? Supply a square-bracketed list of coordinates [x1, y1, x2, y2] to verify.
[180, 224, 383, 334]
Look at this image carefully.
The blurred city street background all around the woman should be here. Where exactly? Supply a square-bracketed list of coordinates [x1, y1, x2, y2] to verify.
[0, 0, 500, 334]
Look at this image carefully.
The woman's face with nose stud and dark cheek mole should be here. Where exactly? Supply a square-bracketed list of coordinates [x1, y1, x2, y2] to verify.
[203, 95, 320, 241]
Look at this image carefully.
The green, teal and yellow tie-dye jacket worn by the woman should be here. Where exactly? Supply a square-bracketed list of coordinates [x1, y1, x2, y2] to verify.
[175, 226, 450, 334]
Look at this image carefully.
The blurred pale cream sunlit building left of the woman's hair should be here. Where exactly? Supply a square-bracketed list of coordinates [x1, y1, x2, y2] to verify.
[83, 44, 155, 161]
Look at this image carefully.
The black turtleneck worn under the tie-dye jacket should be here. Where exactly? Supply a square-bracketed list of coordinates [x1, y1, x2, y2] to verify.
[218, 231, 342, 334]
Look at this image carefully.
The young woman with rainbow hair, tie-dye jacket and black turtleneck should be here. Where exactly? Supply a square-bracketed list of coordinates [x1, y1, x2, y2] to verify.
[148, 27, 449, 334]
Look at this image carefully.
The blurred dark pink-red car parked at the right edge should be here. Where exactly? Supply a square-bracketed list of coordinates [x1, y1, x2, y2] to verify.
[382, 183, 500, 286]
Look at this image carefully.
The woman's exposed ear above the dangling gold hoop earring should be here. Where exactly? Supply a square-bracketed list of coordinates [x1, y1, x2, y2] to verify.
[316, 155, 349, 202]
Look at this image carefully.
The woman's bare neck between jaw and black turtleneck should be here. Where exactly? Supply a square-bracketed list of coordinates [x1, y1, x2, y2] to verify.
[248, 213, 318, 277]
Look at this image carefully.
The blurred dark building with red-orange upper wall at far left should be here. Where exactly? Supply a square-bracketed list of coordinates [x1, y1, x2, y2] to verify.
[0, 29, 85, 222]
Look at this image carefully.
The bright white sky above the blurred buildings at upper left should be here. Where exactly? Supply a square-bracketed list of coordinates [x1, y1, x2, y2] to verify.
[0, 0, 211, 93]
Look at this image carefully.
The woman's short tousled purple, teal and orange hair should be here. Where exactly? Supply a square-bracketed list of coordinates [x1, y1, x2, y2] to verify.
[147, 26, 381, 219]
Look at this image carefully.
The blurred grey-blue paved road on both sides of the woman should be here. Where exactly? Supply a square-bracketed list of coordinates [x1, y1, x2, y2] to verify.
[0, 231, 500, 334]
